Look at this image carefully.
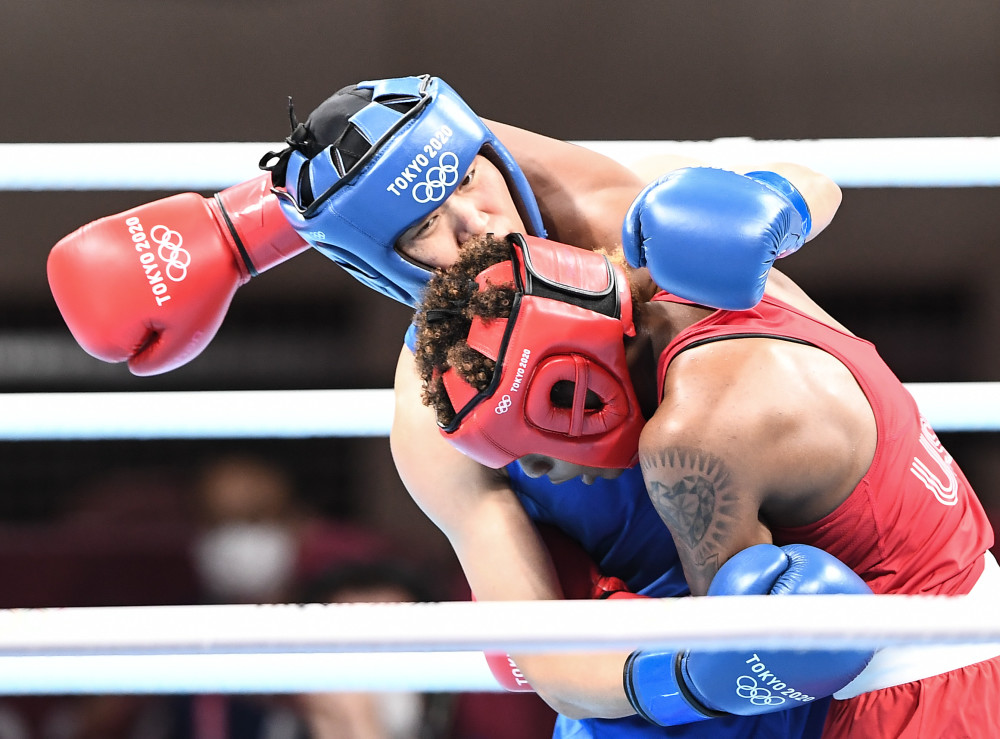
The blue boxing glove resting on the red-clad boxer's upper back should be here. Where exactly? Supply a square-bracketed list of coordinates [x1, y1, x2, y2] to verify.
[622, 167, 812, 310]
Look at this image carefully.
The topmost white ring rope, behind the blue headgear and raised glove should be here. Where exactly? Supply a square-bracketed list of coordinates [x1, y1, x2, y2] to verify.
[0, 137, 1000, 191]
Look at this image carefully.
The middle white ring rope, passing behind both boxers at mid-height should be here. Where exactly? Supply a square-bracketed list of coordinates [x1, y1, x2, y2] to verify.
[0, 382, 1000, 441]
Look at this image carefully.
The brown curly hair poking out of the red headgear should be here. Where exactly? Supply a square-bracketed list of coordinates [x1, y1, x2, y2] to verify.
[416, 234, 514, 425]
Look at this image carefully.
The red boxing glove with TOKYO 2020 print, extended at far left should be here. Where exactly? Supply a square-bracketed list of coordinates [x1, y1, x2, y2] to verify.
[48, 174, 309, 376]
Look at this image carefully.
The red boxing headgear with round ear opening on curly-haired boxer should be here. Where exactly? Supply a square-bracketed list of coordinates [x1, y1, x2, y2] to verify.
[442, 234, 645, 469]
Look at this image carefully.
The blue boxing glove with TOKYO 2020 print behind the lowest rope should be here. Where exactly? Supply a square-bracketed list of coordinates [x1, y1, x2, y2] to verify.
[625, 544, 873, 726]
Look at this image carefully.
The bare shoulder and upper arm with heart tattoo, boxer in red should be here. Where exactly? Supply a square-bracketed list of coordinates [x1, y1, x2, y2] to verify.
[640, 338, 875, 595]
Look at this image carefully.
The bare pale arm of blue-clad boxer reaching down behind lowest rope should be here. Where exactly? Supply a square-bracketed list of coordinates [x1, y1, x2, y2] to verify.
[390, 347, 633, 718]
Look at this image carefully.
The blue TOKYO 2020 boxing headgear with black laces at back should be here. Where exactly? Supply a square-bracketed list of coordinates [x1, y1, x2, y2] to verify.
[261, 75, 545, 306]
